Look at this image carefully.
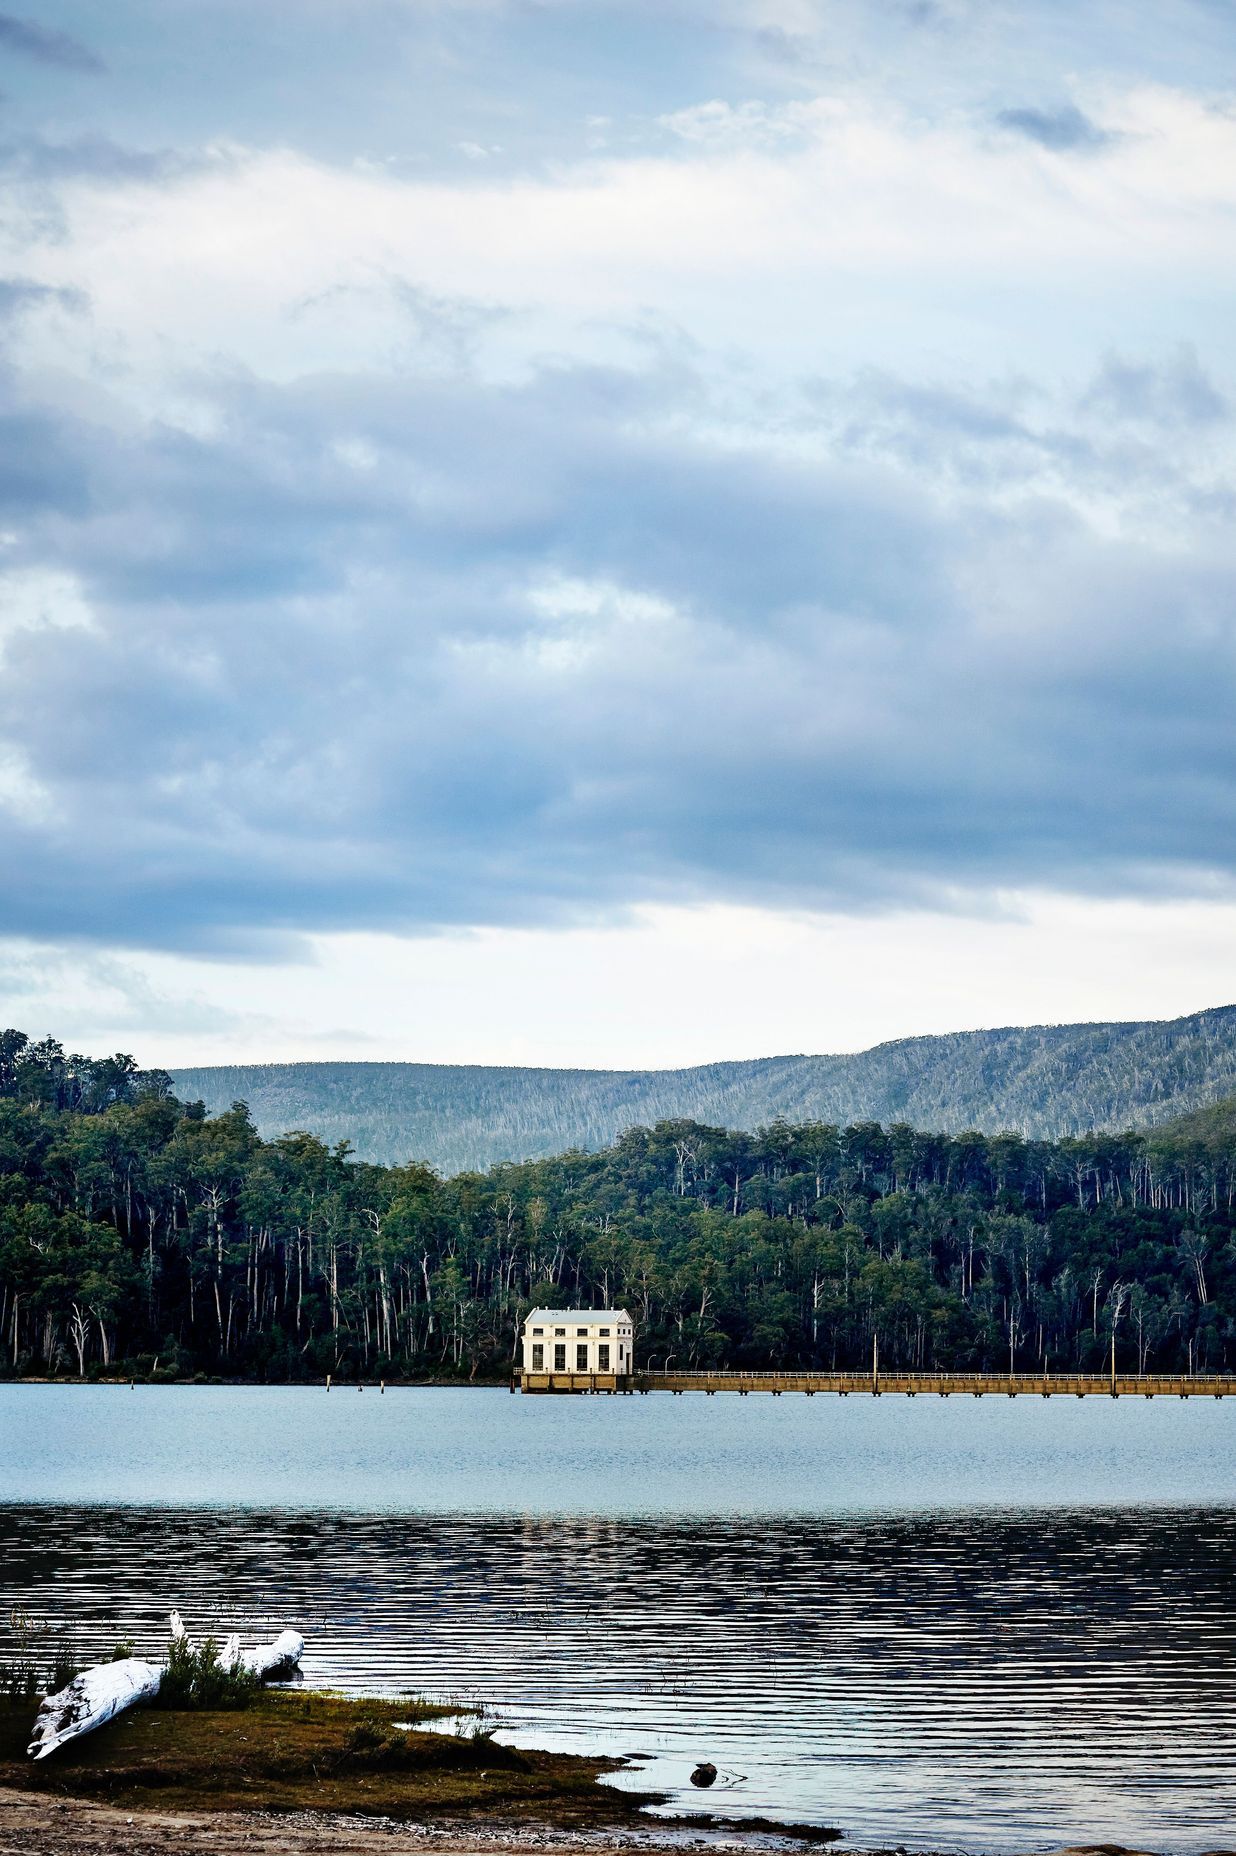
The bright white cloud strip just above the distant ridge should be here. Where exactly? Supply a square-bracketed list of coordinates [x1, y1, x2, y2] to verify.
[0, 893, 1236, 1069]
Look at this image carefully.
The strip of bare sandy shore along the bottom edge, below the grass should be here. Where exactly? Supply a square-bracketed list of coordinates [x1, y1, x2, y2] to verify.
[0, 1787, 1195, 1856]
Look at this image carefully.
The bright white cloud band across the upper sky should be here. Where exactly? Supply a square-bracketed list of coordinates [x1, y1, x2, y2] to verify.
[7, 85, 1236, 391]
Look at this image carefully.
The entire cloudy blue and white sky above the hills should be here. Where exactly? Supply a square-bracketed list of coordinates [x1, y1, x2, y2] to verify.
[0, 0, 1236, 1065]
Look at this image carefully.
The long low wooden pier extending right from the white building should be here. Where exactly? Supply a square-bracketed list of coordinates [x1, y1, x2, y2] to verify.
[510, 1368, 1236, 1398]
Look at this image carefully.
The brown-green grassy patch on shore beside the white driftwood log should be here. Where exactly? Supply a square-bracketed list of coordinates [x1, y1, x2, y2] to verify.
[0, 1689, 646, 1828]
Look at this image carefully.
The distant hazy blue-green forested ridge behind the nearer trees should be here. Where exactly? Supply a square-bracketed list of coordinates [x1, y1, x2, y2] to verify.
[173, 1006, 1236, 1173]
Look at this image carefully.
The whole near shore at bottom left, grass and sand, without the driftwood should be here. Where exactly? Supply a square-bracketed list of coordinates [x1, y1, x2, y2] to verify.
[0, 1689, 1236, 1856]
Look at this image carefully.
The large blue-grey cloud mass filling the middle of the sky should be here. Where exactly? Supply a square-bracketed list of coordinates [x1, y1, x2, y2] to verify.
[0, 358, 1236, 954]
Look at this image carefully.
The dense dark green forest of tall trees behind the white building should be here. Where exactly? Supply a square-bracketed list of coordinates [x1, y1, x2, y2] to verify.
[0, 1032, 1236, 1381]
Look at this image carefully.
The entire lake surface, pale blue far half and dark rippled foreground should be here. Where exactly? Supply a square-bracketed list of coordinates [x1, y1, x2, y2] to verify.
[0, 1386, 1236, 1852]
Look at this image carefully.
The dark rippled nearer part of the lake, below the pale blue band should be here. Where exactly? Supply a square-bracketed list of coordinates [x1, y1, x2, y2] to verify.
[0, 1505, 1236, 1850]
